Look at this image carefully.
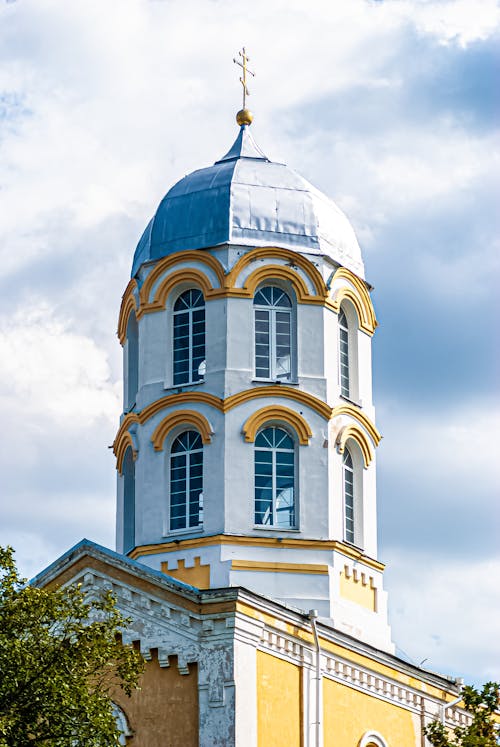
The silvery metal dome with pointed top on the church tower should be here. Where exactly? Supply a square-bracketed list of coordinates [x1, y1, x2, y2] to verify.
[132, 125, 364, 277]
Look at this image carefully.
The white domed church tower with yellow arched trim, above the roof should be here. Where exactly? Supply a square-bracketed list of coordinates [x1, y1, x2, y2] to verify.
[114, 110, 393, 652]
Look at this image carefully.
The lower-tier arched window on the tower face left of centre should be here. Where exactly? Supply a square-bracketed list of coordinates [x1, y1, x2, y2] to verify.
[170, 431, 203, 530]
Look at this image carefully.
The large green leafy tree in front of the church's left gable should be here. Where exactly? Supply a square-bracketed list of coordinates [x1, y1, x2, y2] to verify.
[0, 547, 143, 747]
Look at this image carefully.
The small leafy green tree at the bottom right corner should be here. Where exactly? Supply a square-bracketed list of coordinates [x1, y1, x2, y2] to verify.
[425, 682, 500, 747]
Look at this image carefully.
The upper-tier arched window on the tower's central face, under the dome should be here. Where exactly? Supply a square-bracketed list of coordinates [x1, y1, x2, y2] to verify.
[253, 285, 293, 380]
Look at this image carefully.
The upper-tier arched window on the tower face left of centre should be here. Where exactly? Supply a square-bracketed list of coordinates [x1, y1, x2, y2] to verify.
[173, 288, 205, 386]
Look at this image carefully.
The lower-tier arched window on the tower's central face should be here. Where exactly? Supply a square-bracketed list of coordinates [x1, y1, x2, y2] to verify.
[255, 426, 296, 529]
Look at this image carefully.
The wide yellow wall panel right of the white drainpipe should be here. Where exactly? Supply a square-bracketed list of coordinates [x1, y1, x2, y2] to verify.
[323, 678, 420, 747]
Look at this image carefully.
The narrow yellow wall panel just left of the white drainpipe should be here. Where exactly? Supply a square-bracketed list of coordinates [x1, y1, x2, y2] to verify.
[257, 651, 302, 747]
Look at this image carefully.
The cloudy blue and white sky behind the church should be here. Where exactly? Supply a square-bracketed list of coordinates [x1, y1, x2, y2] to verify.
[0, 0, 500, 683]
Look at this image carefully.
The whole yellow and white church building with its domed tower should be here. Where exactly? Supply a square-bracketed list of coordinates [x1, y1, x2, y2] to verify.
[35, 96, 467, 747]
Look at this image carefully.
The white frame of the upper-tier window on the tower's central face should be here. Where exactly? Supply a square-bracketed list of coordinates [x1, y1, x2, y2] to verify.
[252, 278, 297, 384]
